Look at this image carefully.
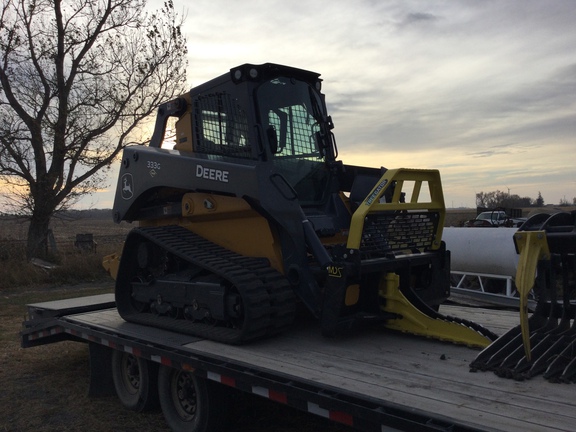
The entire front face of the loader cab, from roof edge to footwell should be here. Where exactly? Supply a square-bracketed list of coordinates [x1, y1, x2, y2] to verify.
[244, 68, 350, 238]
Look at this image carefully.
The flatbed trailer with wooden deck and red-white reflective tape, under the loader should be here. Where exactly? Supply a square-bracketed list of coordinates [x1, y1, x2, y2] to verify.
[21, 294, 576, 432]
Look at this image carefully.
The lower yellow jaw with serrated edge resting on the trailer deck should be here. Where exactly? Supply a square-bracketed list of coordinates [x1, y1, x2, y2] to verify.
[379, 273, 492, 348]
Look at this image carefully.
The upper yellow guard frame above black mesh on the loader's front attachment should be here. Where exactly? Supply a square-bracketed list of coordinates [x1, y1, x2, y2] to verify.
[347, 168, 446, 249]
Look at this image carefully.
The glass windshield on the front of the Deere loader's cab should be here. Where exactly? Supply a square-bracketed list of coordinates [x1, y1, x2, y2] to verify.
[257, 77, 329, 205]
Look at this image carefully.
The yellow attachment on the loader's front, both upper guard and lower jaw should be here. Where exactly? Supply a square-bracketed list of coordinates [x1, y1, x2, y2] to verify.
[347, 168, 496, 348]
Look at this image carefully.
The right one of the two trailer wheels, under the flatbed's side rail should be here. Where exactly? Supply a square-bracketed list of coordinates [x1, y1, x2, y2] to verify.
[158, 366, 230, 432]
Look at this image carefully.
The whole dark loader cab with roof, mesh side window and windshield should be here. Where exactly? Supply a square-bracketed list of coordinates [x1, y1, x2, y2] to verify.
[175, 63, 350, 233]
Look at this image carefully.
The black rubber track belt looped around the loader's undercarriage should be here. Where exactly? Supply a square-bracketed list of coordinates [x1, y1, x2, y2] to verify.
[116, 225, 296, 344]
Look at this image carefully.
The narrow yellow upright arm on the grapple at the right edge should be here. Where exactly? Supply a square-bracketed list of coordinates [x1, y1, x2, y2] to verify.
[514, 231, 550, 360]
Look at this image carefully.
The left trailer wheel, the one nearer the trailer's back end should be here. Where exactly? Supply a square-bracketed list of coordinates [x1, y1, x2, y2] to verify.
[112, 350, 158, 412]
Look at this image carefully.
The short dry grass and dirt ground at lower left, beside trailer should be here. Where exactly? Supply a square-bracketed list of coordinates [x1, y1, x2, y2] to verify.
[0, 284, 166, 432]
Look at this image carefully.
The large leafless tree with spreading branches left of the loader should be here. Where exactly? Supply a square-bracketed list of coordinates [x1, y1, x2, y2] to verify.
[0, 0, 187, 257]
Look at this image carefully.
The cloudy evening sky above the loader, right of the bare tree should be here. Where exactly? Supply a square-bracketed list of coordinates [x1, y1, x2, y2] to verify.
[80, 0, 576, 208]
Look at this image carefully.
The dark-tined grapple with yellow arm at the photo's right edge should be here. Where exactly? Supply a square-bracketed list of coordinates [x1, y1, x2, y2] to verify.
[470, 212, 576, 382]
